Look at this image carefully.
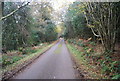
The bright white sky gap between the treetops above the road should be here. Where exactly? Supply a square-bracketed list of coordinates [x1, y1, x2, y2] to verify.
[31, 0, 76, 24]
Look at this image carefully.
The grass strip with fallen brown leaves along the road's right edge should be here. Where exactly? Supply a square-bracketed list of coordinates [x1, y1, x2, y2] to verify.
[67, 43, 107, 79]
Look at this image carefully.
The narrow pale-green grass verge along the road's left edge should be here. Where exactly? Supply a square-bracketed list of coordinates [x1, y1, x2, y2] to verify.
[1, 42, 56, 80]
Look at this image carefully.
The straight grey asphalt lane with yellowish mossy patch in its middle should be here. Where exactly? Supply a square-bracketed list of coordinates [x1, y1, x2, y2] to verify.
[12, 39, 75, 79]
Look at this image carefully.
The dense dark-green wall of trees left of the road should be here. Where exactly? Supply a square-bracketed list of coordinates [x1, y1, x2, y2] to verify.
[2, 2, 57, 50]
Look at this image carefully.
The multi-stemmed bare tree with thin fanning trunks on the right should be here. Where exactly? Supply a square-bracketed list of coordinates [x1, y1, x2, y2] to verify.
[83, 2, 120, 52]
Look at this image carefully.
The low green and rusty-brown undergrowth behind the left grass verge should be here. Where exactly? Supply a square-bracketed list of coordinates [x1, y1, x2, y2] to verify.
[2, 43, 48, 68]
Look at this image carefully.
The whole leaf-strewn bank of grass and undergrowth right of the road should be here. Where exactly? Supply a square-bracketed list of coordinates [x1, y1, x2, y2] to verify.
[67, 38, 120, 79]
